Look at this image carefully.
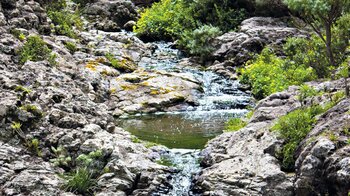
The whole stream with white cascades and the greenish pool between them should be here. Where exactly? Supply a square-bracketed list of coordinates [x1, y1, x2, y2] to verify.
[119, 42, 251, 196]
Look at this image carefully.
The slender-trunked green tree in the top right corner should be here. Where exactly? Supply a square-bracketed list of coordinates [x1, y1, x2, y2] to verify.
[284, 0, 350, 66]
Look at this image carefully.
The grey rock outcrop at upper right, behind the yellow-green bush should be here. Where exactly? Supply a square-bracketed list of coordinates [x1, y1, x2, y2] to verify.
[208, 17, 306, 69]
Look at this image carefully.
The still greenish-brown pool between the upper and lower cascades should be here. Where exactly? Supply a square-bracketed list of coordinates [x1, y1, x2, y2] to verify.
[118, 110, 245, 149]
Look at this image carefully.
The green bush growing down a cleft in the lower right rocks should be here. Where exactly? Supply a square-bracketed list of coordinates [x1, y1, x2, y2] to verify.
[272, 106, 324, 171]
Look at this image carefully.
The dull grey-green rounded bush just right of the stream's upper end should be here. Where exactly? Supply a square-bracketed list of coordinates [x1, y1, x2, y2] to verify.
[179, 25, 221, 59]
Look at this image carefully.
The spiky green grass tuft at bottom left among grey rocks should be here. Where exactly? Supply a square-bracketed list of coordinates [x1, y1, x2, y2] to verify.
[64, 167, 97, 195]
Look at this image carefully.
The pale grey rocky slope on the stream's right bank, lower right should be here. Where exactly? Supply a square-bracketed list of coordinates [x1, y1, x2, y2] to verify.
[196, 80, 350, 195]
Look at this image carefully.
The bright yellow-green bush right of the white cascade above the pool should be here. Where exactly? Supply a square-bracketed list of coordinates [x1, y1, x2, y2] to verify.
[241, 48, 315, 99]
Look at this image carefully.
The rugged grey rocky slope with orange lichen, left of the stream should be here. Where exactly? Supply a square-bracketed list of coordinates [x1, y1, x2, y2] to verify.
[0, 0, 189, 195]
